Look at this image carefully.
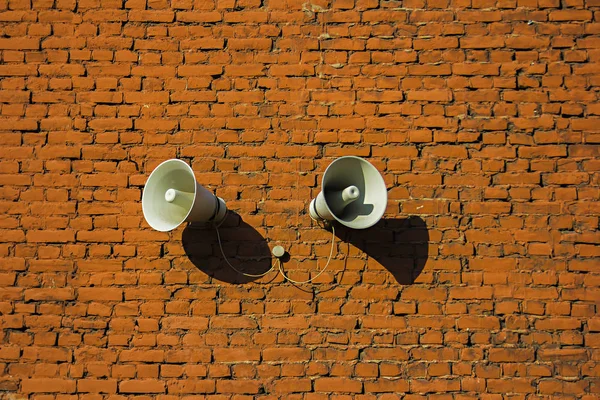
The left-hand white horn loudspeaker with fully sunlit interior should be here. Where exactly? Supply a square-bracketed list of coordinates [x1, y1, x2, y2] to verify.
[142, 159, 227, 232]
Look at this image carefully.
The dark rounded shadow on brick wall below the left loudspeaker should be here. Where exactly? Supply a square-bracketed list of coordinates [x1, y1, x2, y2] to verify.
[181, 210, 272, 283]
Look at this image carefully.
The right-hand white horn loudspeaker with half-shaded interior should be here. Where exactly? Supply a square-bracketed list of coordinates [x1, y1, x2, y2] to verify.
[310, 156, 387, 229]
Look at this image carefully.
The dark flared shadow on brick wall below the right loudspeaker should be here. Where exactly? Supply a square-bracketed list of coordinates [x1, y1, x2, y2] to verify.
[336, 216, 429, 285]
